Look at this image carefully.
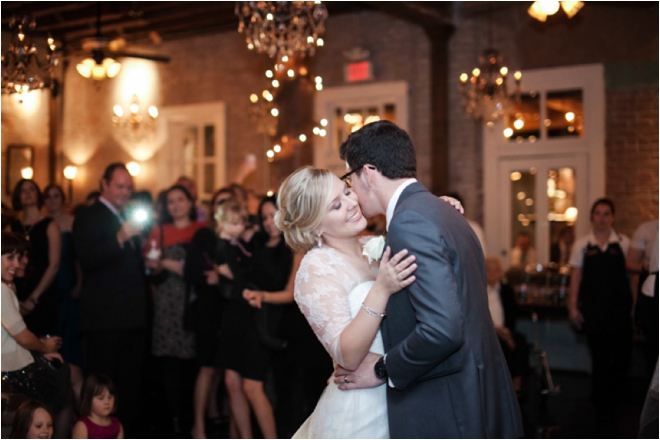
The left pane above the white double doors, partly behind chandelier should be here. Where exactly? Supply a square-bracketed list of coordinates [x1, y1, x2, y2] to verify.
[504, 92, 541, 142]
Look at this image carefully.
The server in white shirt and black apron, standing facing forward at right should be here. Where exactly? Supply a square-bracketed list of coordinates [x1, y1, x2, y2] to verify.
[568, 198, 633, 428]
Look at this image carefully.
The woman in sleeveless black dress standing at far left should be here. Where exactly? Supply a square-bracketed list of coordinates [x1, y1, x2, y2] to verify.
[10, 179, 62, 336]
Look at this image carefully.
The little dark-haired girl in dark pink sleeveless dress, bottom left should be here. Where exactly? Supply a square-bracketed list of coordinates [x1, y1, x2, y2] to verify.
[72, 374, 124, 438]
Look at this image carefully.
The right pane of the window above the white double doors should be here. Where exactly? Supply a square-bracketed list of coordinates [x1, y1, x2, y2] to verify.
[545, 89, 584, 138]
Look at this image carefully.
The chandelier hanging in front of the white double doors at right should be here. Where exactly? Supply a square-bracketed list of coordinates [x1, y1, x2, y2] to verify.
[459, 49, 522, 125]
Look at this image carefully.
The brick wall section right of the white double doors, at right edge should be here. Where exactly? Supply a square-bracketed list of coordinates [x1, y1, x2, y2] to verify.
[605, 88, 658, 236]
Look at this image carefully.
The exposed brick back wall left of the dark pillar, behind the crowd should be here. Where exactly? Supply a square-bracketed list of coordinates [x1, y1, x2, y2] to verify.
[52, 12, 432, 200]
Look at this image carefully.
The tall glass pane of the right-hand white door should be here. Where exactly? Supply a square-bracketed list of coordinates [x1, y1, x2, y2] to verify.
[547, 168, 578, 265]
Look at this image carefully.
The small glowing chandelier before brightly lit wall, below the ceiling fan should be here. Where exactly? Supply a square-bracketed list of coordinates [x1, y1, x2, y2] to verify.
[112, 95, 158, 145]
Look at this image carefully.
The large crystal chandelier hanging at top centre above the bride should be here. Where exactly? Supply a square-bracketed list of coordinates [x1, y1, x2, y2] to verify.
[235, 2, 328, 63]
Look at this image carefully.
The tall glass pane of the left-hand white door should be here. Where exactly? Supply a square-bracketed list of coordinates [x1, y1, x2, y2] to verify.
[510, 168, 536, 254]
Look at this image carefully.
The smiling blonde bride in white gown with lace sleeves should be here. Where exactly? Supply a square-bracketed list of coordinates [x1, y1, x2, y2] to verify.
[275, 167, 417, 438]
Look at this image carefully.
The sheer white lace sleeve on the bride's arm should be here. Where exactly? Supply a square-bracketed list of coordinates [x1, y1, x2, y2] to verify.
[294, 249, 351, 365]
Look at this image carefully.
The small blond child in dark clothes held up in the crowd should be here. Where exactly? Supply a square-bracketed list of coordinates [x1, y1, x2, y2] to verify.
[215, 200, 286, 350]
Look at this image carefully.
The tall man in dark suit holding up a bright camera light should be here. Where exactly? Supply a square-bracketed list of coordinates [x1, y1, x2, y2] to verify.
[73, 163, 147, 429]
